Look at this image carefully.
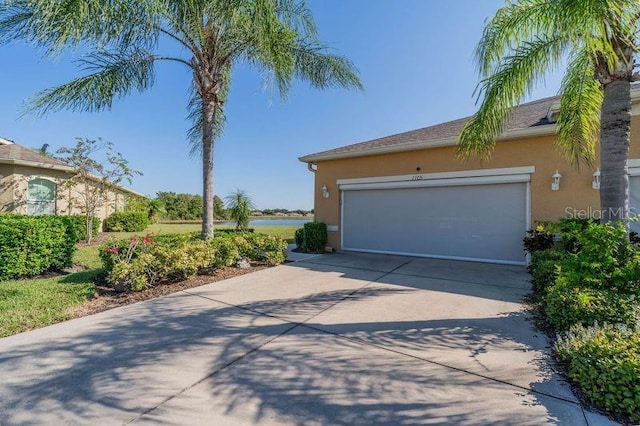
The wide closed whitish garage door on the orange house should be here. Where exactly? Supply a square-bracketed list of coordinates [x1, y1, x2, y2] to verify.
[342, 178, 528, 264]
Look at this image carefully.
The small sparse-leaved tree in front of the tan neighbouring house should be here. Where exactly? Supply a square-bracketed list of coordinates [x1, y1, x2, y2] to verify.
[56, 138, 142, 243]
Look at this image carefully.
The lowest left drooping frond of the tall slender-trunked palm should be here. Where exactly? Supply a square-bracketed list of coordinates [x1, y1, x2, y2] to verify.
[27, 49, 156, 114]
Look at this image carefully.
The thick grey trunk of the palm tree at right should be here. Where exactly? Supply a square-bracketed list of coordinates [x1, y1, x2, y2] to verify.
[600, 80, 631, 226]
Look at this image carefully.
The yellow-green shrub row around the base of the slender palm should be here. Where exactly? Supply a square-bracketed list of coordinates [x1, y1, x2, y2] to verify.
[100, 233, 287, 291]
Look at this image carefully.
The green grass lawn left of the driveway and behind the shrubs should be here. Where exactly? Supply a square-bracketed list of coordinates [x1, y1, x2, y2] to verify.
[0, 224, 299, 337]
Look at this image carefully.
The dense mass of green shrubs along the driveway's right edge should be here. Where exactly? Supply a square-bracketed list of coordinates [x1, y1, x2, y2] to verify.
[529, 220, 640, 422]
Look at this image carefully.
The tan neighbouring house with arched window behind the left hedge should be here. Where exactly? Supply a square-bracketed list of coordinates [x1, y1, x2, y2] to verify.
[0, 138, 143, 220]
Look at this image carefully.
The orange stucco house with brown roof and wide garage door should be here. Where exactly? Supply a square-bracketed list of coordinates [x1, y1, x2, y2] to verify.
[300, 88, 640, 264]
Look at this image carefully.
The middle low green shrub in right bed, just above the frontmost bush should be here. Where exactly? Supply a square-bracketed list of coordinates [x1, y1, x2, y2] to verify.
[544, 282, 640, 331]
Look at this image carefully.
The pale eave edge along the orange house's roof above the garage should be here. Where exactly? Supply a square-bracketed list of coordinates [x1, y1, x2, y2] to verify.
[298, 124, 557, 163]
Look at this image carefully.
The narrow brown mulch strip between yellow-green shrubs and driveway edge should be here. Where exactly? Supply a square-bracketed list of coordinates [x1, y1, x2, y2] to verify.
[69, 263, 268, 318]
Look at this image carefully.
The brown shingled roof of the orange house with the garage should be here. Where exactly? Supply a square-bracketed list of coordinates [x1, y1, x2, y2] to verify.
[300, 96, 560, 163]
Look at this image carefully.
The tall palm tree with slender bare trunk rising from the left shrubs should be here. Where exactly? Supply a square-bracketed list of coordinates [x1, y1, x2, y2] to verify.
[0, 0, 362, 238]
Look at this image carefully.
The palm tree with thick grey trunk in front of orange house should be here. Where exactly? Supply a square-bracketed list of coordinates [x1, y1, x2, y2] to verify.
[457, 0, 640, 223]
